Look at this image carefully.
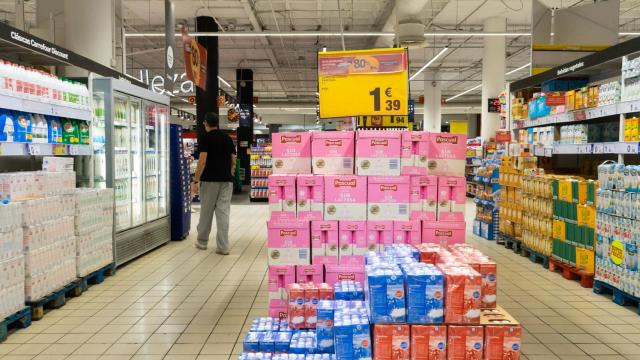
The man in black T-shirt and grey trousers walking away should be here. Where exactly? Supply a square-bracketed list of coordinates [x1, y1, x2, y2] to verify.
[196, 112, 236, 255]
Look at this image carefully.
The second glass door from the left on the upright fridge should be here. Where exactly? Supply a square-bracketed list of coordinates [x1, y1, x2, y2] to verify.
[129, 98, 144, 226]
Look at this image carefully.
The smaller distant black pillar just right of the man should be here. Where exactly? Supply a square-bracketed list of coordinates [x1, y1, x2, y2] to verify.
[236, 69, 253, 185]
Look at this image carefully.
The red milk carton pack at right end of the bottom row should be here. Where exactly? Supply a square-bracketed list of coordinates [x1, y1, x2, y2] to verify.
[484, 325, 522, 360]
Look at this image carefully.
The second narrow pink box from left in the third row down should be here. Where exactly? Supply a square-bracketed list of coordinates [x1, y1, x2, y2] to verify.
[338, 221, 368, 266]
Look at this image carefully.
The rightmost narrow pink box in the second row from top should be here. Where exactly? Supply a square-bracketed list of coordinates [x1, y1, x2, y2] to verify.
[438, 176, 467, 221]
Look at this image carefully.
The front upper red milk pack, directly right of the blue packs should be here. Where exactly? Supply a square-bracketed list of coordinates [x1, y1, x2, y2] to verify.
[440, 265, 482, 324]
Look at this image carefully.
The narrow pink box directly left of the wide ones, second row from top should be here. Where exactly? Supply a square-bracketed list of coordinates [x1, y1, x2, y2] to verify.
[296, 175, 324, 220]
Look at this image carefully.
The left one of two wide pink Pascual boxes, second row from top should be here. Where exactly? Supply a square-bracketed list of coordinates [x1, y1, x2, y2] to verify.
[324, 175, 367, 220]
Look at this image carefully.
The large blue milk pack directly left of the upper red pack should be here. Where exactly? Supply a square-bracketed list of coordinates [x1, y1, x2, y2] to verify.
[401, 263, 444, 324]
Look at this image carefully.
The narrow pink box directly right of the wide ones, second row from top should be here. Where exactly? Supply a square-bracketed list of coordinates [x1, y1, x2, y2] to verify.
[409, 175, 438, 220]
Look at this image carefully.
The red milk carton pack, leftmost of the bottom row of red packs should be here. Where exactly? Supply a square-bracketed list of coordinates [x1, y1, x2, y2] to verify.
[373, 324, 411, 360]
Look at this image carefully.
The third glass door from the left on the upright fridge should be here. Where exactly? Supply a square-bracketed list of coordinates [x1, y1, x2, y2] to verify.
[144, 103, 158, 221]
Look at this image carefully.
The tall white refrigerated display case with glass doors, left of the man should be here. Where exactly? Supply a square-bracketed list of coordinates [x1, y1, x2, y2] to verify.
[93, 78, 170, 265]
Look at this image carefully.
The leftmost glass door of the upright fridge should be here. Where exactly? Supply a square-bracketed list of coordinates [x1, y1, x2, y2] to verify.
[111, 93, 131, 231]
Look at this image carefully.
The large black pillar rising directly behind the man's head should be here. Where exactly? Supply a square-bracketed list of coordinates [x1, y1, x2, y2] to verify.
[196, 16, 218, 143]
